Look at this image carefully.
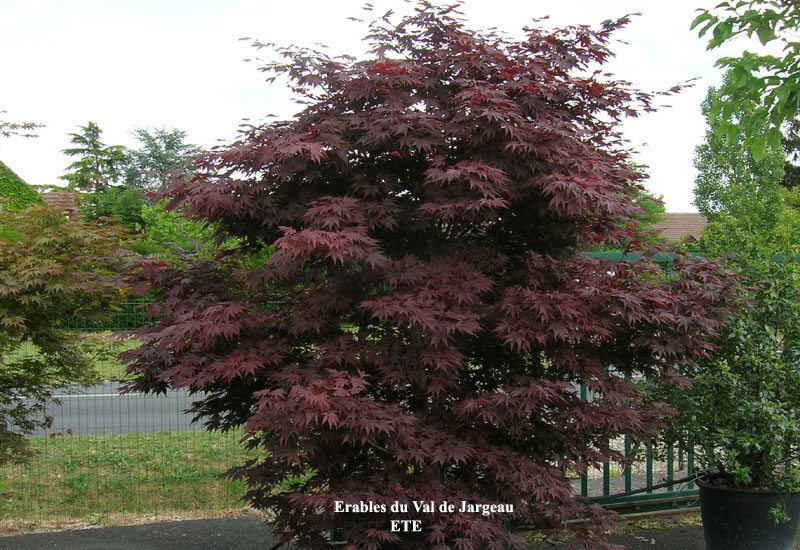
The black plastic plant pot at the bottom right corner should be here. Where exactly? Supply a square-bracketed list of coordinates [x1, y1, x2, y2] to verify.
[697, 481, 800, 550]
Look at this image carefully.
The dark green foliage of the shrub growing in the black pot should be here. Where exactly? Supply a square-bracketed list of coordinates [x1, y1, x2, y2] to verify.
[655, 233, 800, 492]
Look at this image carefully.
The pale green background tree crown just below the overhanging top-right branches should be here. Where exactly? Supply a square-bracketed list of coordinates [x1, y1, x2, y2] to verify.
[694, 83, 786, 232]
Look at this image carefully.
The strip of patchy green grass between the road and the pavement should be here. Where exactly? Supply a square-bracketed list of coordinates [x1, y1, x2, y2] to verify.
[0, 432, 252, 534]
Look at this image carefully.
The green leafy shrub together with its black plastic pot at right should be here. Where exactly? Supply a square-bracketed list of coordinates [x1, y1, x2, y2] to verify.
[654, 246, 800, 550]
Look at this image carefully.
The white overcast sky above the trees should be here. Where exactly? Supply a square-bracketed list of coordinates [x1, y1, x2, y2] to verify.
[0, 0, 742, 212]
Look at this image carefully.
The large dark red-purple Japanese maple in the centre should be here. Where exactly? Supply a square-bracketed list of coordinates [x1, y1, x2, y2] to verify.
[127, 2, 730, 550]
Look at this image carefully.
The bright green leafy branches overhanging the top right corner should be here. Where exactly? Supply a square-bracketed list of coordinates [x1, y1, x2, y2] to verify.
[691, 0, 800, 160]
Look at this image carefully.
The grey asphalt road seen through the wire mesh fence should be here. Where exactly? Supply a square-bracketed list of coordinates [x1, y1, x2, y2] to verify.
[26, 382, 203, 435]
